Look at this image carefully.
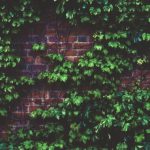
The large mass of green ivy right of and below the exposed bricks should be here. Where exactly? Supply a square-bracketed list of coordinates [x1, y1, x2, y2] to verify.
[0, 0, 150, 150]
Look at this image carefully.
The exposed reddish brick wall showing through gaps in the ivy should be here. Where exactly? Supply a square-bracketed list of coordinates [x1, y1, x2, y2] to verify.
[0, 18, 150, 138]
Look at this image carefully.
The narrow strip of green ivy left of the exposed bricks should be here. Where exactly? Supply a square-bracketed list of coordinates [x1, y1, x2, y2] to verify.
[0, 0, 39, 118]
